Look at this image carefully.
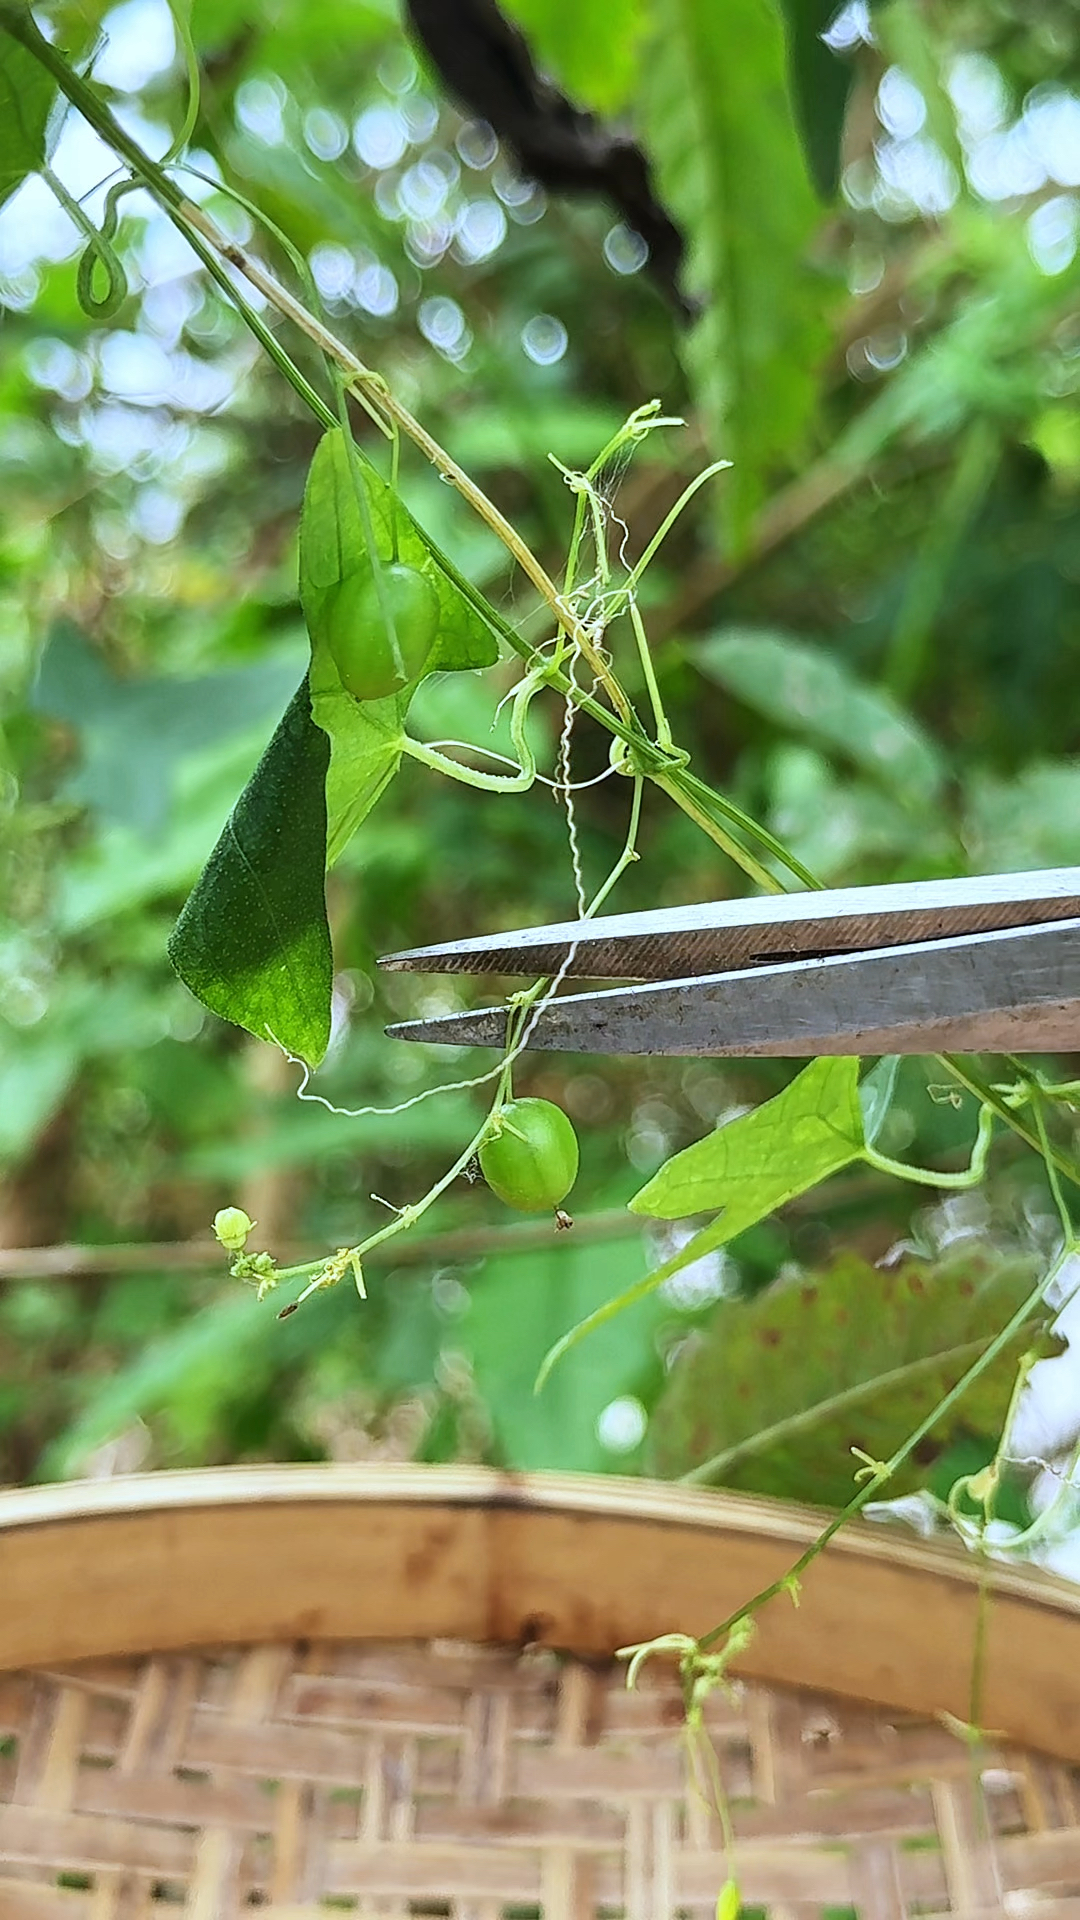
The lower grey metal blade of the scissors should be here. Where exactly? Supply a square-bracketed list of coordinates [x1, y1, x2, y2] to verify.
[386, 918, 1080, 1058]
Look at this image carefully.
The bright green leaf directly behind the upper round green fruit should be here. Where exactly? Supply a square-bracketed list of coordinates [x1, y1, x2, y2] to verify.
[300, 428, 498, 866]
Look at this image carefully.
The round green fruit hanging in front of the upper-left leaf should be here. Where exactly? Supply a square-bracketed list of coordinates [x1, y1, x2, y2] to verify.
[327, 564, 438, 701]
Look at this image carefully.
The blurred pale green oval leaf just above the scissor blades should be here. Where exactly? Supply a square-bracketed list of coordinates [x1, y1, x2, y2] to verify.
[688, 628, 942, 806]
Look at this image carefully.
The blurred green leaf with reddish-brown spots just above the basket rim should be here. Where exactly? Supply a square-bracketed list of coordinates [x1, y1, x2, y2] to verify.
[650, 1252, 1038, 1507]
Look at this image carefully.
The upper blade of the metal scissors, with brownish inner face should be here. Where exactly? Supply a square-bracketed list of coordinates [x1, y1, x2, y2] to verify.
[379, 866, 1080, 981]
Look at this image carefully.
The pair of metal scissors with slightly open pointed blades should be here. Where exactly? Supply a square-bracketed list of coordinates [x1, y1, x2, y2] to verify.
[380, 866, 1080, 1058]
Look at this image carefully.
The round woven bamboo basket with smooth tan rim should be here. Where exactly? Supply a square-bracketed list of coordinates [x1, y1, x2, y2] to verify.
[0, 1467, 1080, 1920]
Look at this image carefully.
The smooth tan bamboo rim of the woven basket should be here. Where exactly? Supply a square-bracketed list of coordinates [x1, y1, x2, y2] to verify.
[0, 1465, 1080, 1763]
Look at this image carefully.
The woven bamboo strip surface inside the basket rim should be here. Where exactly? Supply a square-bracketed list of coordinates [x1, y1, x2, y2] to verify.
[0, 1644, 1080, 1920]
